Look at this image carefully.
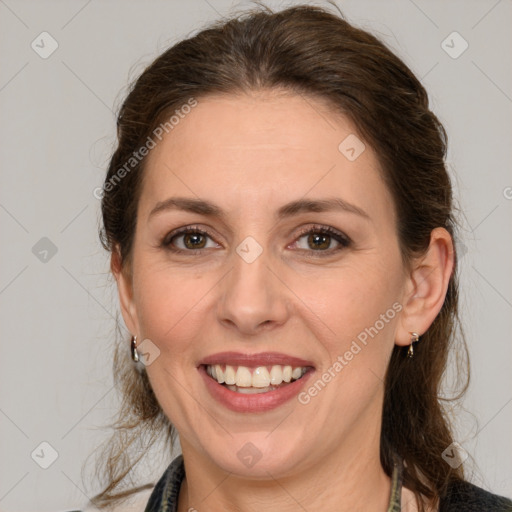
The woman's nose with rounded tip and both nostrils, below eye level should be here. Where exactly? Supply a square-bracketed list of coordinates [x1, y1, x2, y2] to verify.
[218, 244, 290, 335]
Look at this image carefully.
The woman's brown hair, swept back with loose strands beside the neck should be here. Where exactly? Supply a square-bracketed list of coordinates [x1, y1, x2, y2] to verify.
[93, 5, 469, 510]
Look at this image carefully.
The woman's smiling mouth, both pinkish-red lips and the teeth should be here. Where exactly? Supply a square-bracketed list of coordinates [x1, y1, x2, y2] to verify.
[198, 352, 315, 412]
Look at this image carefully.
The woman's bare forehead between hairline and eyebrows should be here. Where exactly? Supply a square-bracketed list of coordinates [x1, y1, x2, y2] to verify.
[140, 91, 390, 225]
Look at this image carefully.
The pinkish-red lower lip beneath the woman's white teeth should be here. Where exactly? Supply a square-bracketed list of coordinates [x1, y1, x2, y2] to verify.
[198, 365, 314, 412]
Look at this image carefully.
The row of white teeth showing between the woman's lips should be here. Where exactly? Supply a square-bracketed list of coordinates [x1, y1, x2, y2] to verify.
[206, 364, 307, 393]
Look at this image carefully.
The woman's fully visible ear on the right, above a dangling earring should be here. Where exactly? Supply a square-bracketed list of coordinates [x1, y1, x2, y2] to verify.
[395, 228, 454, 346]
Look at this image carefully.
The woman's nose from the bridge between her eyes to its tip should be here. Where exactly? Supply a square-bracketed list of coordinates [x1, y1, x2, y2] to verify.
[218, 236, 287, 333]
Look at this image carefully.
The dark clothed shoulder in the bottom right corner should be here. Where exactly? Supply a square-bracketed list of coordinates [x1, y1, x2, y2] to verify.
[439, 481, 512, 512]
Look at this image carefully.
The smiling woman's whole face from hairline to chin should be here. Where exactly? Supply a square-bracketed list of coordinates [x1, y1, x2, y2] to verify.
[120, 91, 406, 477]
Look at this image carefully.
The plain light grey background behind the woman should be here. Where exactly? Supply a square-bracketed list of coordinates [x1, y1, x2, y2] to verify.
[0, 0, 512, 512]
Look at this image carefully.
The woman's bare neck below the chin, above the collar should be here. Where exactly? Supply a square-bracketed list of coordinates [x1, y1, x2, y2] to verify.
[178, 414, 391, 512]
